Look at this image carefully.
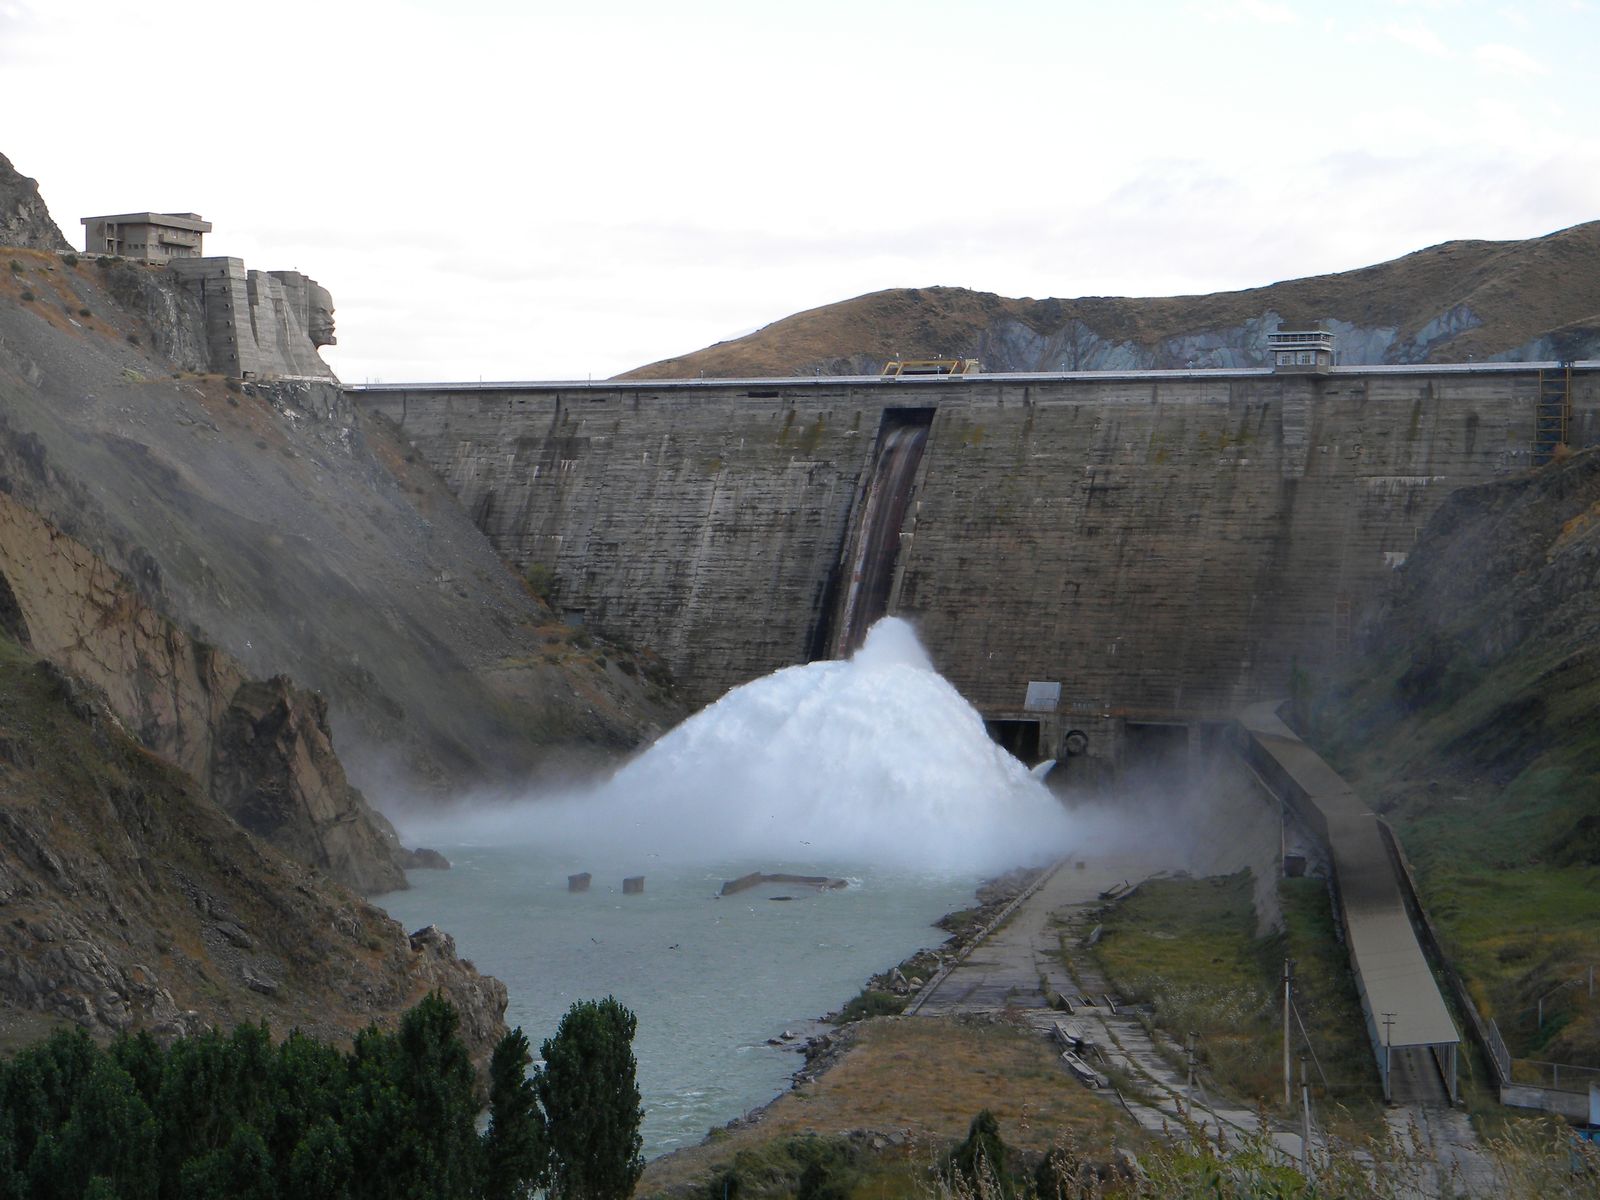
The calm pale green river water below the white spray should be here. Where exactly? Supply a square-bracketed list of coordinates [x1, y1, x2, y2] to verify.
[382, 840, 978, 1157]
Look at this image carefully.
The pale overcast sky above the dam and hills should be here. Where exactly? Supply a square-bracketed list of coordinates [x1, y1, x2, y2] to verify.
[0, 0, 1600, 382]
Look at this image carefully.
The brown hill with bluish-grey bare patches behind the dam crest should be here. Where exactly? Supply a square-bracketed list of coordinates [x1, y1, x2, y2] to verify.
[619, 221, 1600, 379]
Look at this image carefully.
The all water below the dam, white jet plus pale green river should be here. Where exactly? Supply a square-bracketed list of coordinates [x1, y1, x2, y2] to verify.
[384, 618, 1074, 1155]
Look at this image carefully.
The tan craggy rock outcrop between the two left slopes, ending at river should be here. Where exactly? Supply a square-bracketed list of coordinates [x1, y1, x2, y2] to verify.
[0, 494, 406, 894]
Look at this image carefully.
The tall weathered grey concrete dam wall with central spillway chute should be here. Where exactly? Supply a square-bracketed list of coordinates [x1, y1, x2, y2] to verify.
[349, 355, 1600, 771]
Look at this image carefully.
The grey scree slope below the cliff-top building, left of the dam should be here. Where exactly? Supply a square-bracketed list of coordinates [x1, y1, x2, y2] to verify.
[0, 250, 677, 806]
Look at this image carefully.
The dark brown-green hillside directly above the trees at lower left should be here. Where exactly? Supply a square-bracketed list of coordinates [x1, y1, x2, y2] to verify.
[0, 635, 506, 1059]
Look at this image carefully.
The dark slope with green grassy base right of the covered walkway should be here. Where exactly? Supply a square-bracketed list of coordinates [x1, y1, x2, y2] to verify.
[1310, 450, 1600, 1062]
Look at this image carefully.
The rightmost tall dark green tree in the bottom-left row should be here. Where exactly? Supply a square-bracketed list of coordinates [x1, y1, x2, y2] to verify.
[534, 995, 645, 1200]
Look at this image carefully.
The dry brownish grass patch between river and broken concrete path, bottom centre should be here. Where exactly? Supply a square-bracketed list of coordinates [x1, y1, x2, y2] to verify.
[640, 1018, 1139, 1195]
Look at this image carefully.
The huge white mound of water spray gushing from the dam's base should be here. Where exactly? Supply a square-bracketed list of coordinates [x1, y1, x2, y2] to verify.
[419, 618, 1072, 872]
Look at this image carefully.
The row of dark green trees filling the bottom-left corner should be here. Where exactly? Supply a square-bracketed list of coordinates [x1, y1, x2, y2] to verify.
[0, 995, 640, 1200]
